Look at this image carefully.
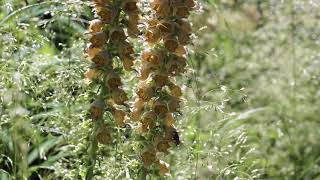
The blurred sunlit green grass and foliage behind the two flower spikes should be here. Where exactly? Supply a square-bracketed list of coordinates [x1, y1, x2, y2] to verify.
[0, 0, 320, 180]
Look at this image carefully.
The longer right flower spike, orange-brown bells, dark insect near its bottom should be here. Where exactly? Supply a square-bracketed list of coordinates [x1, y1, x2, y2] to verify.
[131, 0, 198, 175]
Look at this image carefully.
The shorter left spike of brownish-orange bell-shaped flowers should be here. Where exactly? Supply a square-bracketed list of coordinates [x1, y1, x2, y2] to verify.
[85, 0, 140, 148]
